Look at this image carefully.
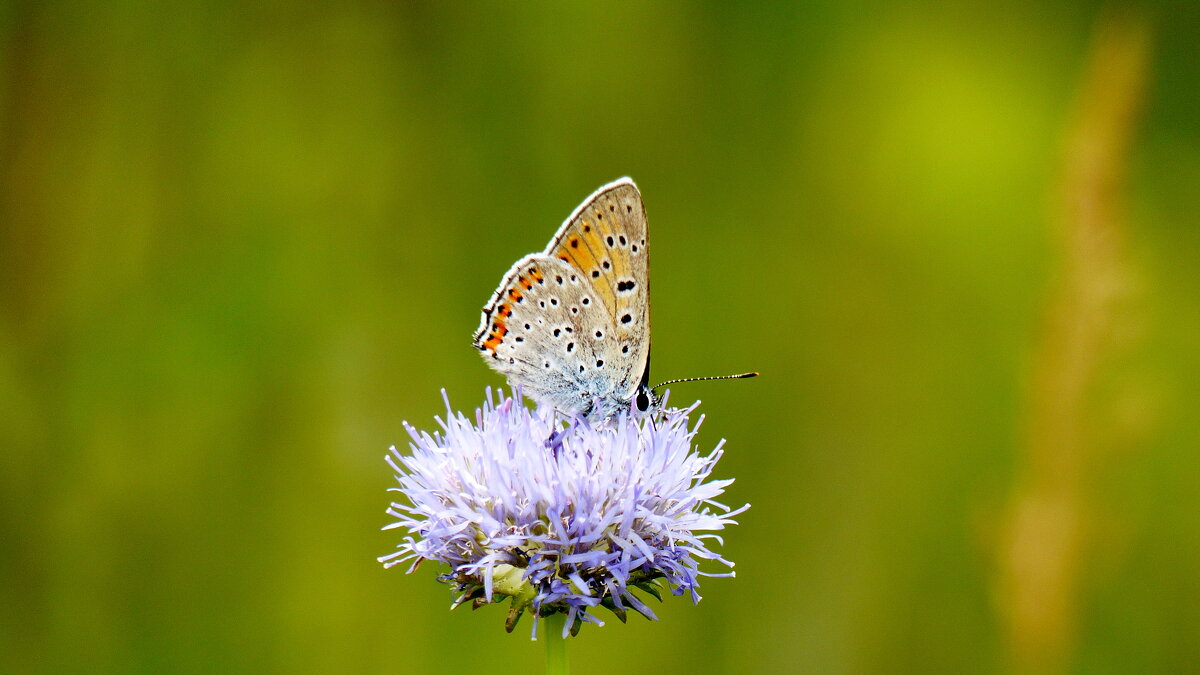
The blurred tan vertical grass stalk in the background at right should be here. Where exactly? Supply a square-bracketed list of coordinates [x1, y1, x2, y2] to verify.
[996, 16, 1150, 673]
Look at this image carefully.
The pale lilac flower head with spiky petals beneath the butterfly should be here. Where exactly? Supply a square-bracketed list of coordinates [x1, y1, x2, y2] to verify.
[379, 390, 749, 635]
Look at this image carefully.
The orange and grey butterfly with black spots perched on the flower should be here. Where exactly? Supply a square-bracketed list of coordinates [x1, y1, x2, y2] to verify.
[474, 178, 659, 418]
